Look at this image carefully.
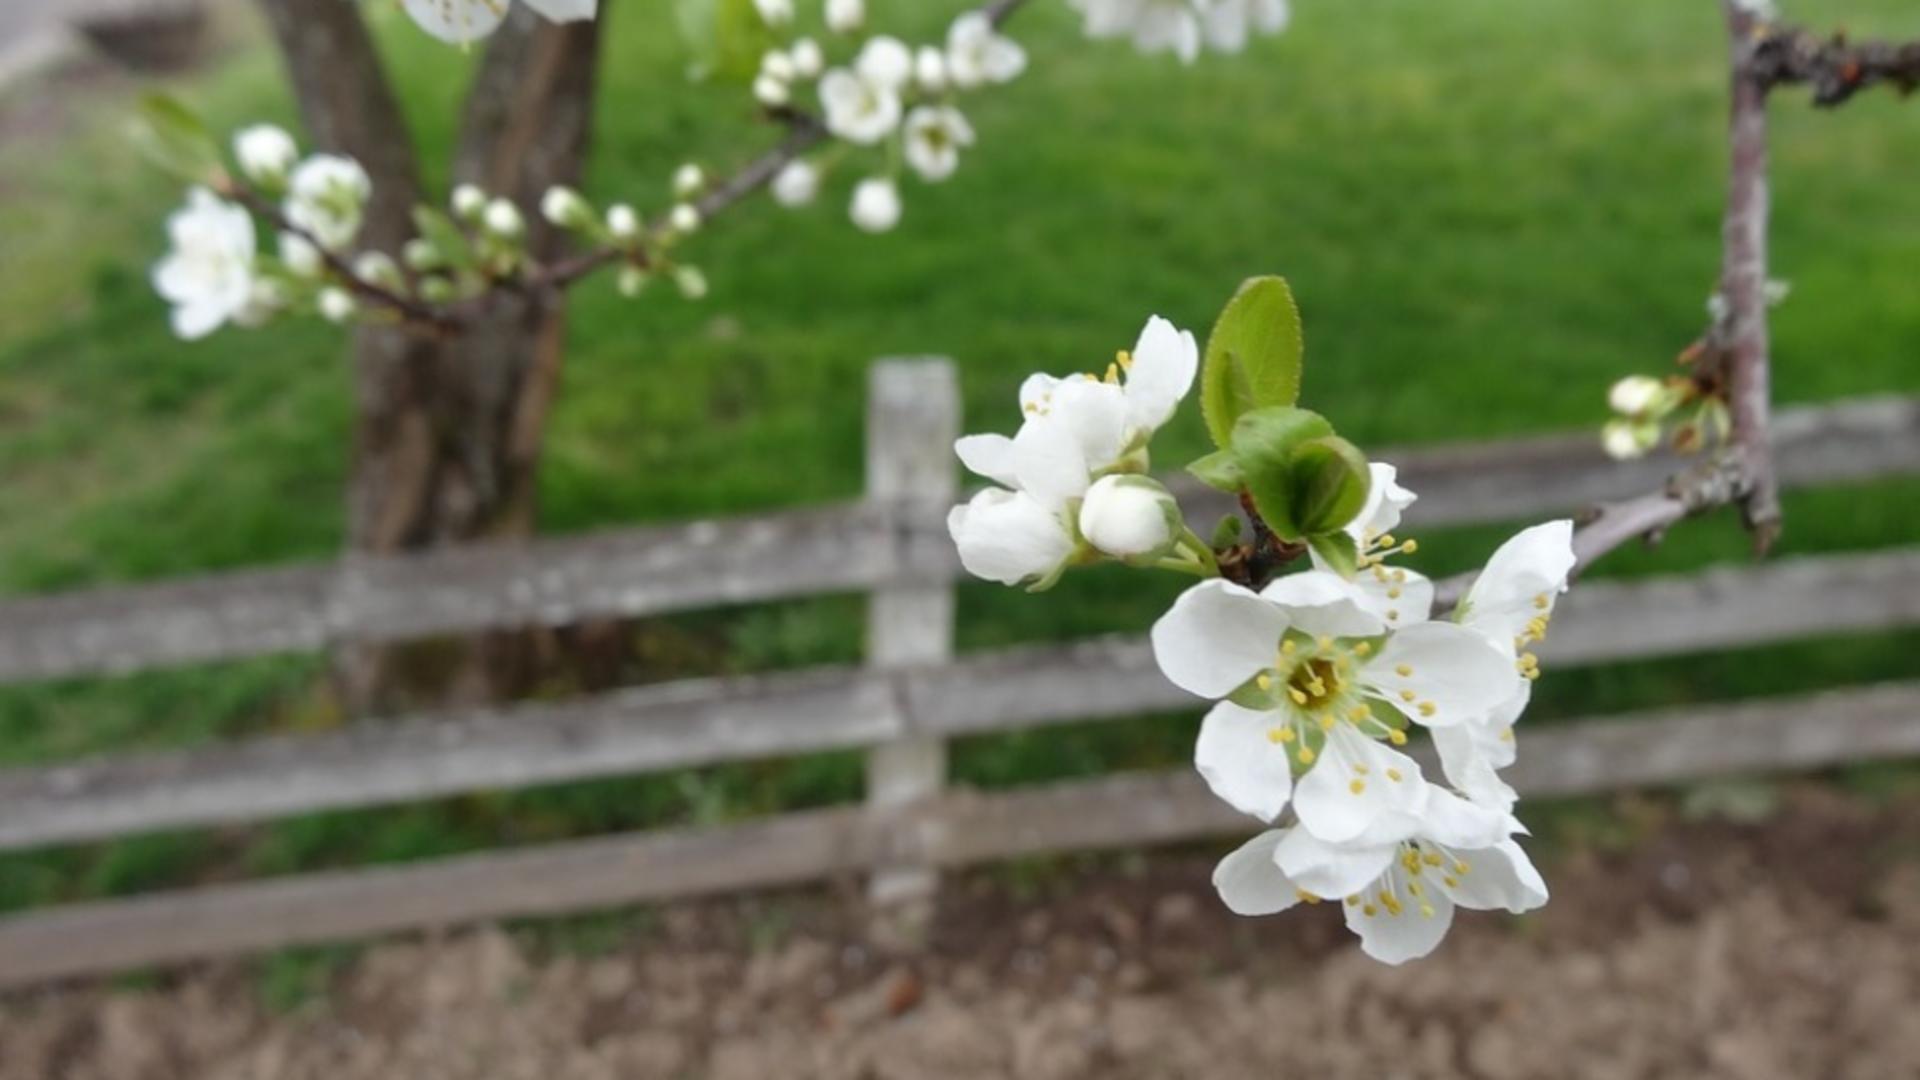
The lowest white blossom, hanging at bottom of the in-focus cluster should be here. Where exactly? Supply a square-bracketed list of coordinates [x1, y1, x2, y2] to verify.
[1213, 788, 1548, 965]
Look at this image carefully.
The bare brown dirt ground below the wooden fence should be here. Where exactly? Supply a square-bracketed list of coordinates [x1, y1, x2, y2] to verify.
[0, 788, 1920, 1080]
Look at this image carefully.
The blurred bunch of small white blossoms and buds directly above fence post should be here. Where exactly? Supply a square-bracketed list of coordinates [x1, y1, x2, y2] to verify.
[753, 0, 1027, 233]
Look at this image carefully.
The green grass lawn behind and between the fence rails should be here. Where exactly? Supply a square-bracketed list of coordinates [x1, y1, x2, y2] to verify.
[0, 0, 1920, 907]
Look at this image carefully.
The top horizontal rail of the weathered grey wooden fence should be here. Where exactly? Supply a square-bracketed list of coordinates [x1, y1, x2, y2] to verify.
[0, 398, 1920, 682]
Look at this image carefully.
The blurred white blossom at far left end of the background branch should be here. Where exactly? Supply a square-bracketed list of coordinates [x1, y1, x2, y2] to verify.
[154, 188, 255, 340]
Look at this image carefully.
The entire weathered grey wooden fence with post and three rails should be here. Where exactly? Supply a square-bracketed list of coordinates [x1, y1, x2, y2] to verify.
[0, 361, 1920, 984]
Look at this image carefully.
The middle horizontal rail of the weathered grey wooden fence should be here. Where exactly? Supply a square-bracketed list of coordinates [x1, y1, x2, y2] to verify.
[0, 550, 1920, 849]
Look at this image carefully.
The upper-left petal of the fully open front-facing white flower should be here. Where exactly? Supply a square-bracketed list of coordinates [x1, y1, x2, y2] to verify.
[1152, 578, 1286, 698]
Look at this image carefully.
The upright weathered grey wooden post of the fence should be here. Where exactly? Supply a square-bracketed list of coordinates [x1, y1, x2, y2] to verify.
[866, 359, 960, 945]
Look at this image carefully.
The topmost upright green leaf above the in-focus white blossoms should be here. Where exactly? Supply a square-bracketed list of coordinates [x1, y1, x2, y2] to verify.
[1200, 277, 1302, 448]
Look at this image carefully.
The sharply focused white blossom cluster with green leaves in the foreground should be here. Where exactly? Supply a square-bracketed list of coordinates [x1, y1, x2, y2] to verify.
[948, 276, 1574, 963]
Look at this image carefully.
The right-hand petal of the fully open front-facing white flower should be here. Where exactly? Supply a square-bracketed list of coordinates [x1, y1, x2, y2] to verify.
[1359, 623, 1513, 728]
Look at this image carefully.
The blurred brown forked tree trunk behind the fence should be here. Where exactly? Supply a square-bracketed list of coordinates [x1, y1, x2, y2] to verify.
[261, 0, 605, 711]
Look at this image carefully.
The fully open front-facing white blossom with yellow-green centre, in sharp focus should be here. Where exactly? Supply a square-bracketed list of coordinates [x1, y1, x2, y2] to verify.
[1152, 571, 1513, 844]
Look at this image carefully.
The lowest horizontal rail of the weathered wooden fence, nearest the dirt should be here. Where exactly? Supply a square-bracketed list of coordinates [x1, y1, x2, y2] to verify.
[0, 682, 1920, 984]
